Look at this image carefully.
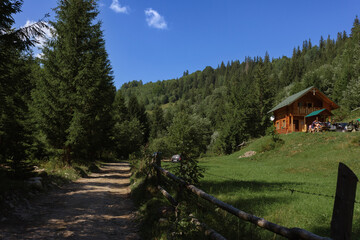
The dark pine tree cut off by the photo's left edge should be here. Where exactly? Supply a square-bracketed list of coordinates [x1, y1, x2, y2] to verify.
[0, 0, 42, 173]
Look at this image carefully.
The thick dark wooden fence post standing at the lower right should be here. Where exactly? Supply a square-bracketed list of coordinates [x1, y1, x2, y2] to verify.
[331, 163, 358, 240]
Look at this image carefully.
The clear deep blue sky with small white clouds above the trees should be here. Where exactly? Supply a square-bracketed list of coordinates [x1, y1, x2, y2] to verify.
[15, 0, 360, 88]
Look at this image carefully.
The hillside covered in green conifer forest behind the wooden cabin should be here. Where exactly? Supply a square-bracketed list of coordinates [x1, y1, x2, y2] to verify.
[117, 17, 360, 156]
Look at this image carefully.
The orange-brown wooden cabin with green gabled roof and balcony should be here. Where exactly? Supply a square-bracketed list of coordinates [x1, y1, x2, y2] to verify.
[269, 87, 339, 133]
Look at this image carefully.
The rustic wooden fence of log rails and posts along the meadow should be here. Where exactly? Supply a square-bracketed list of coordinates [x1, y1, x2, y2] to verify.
[152, 159, 358, 240]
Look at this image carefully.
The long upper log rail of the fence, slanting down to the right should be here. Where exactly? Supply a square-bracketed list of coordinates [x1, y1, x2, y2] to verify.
[153, 163, 332, 240]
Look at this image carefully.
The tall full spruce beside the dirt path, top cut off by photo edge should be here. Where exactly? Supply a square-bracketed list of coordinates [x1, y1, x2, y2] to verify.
[33, 0, 115, 164]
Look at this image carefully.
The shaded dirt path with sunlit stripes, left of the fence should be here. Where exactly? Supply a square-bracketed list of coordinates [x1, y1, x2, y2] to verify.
[0, 163, 140, 240]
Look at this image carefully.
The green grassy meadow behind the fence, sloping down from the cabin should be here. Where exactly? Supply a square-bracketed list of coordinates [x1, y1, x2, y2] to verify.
[167, 133, 360, 239]
